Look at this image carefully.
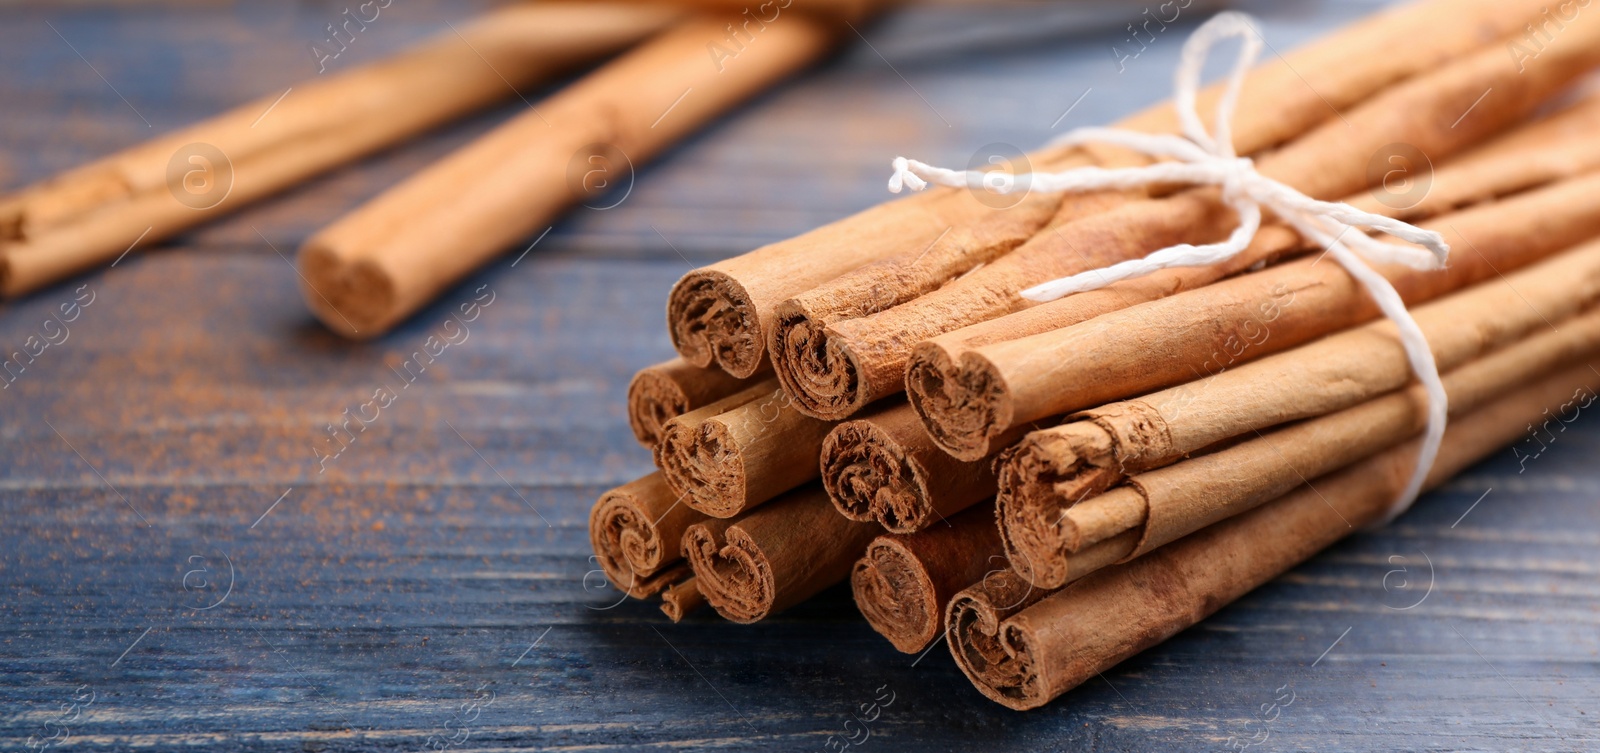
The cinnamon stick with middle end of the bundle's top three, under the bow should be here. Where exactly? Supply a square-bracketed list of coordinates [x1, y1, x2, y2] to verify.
[773, 10, 1600, 425]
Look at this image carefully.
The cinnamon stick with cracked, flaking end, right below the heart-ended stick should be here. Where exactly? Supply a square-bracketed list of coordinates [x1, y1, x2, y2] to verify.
[1000, 236, 1600, 560]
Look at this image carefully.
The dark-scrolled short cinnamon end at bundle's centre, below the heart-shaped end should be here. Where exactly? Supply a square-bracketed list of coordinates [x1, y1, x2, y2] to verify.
[821, 403, 1026, 537]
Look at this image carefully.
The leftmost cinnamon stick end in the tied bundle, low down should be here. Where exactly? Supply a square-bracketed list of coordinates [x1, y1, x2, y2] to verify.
[589, 473, 706, 598]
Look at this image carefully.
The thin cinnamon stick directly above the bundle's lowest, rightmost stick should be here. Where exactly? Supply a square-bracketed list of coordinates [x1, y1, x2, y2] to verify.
[1000, 306, 1600, 588]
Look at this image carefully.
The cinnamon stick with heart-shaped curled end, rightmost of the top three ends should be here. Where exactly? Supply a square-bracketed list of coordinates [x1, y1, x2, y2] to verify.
[910, 174, 1600, 457]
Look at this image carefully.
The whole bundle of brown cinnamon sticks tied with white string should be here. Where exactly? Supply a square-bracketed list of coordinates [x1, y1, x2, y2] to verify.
[590, 0, 1600, 708]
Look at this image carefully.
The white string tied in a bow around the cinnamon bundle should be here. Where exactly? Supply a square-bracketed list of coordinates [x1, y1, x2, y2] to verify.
[890, 11, 1450, 523]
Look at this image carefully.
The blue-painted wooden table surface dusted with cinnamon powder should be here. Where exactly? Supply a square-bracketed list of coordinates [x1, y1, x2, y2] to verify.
[0, 0, 1600, 751]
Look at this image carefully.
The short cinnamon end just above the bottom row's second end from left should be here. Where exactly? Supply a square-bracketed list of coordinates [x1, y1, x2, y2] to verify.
[656, 379, 832, 518]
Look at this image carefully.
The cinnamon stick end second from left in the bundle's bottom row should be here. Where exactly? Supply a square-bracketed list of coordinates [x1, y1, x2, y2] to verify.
[683, 484, 878, 624]
